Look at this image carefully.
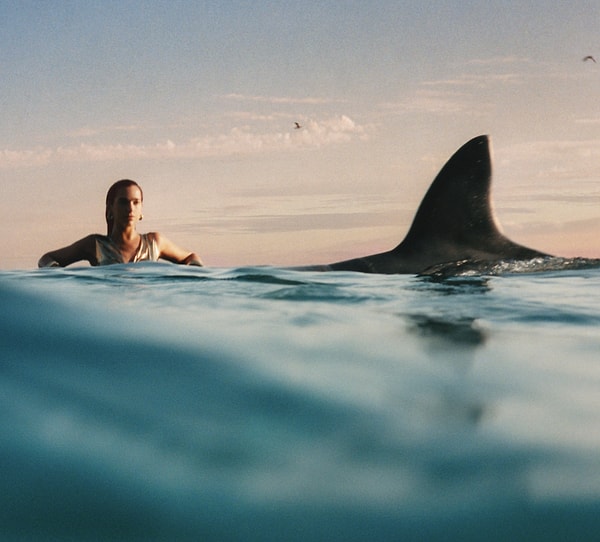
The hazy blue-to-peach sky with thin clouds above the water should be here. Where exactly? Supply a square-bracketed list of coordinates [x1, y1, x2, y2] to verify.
[0, 0, 600, 269]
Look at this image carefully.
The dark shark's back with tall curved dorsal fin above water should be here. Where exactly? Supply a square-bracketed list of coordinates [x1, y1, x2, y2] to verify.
[330, 136, 547, 273]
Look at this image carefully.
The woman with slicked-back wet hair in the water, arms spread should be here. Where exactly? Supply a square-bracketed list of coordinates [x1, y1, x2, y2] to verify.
[38, 179, 202, 267]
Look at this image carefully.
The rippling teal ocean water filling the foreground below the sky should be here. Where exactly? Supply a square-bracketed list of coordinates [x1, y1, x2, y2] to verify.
[0, 259, 600, 542]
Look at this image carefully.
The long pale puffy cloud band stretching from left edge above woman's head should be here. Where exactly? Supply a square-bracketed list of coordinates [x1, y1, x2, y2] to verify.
[0, 115, 367, 168]
